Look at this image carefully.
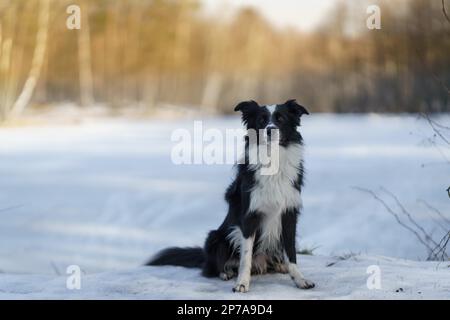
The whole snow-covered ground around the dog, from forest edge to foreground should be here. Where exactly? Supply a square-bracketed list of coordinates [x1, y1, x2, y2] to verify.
[0, 115, 450, 298]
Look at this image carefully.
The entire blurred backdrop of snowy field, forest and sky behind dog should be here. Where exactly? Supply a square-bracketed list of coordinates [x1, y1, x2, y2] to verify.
[0, 0, 450, 274]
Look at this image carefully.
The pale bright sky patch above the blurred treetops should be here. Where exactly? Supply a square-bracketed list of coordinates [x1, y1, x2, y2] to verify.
[203, 0, 337, 31]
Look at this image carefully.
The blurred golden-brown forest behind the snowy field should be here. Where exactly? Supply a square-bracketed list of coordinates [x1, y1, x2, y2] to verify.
[0, 0, 450, 119]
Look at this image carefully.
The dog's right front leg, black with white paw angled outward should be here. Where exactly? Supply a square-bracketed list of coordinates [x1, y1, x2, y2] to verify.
[282, 211, 315, 289]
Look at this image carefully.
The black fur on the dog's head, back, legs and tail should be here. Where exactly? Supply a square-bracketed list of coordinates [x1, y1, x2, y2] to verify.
[147, 100, 309, 284]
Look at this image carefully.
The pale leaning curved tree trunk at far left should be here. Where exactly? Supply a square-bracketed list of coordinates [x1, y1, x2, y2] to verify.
[12, 0, 50, 115]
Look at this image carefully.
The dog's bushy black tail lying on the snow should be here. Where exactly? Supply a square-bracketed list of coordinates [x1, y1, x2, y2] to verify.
[145, 247, 205, 268]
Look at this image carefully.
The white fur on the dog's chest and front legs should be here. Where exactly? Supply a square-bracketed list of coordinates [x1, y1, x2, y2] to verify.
[232, 144, 306, 292]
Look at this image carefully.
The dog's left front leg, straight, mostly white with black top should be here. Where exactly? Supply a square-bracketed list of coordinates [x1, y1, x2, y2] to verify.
[233, 212, 261, 292]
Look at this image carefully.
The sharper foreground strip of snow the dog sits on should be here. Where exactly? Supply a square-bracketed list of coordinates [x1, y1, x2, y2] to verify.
[0, 255, 450, 300]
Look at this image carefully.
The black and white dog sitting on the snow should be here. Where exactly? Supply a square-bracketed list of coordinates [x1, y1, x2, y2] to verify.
[147, 100, 314, 292]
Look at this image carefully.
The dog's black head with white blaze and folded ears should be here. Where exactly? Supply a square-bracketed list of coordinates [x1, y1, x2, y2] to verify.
[234, 100, 309, 145]
